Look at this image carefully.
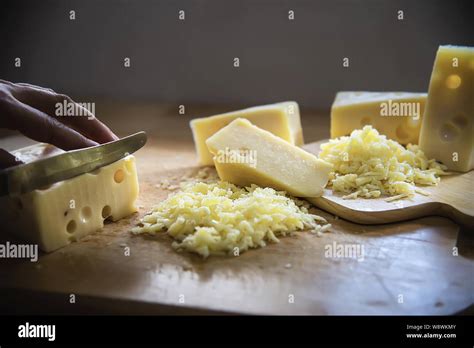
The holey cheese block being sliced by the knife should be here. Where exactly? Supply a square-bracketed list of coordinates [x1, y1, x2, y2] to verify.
[0, 144, 138, 252]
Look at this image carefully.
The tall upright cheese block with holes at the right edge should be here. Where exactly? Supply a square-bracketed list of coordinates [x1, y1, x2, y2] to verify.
[420, 46, 474, 172]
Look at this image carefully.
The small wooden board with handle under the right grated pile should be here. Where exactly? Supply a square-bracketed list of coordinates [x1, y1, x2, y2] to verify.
[304, 140, 474, 229]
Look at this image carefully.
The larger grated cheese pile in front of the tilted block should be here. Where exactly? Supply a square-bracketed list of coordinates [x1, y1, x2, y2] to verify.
[132, 181, 331, 257]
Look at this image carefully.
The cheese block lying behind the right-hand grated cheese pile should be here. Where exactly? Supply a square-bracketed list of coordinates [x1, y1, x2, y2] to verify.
[331, 92, 427, 145]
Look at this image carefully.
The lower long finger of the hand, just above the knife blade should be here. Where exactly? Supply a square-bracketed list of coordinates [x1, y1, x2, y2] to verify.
[2, 101, 98, 150]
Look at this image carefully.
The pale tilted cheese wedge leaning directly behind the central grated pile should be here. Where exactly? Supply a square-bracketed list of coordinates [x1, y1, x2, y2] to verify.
[206, 118, 332, 197]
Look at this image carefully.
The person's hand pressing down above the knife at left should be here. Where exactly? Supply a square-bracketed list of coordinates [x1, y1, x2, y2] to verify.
[0, 80, 118, 169]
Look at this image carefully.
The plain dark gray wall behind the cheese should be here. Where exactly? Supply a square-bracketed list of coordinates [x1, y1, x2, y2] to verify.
[0, 0, 474, 108]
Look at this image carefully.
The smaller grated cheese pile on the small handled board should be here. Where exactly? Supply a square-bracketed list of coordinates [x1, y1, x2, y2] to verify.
[319, 126, 447, 201]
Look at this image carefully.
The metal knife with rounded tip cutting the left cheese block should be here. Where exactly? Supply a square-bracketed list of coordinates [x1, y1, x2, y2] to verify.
[0, 132, 147, 196]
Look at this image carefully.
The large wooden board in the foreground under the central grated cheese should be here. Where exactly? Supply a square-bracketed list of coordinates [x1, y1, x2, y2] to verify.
[0, 138, 474, 314]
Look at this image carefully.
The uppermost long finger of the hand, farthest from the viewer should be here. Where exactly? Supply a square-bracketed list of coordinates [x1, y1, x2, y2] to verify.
[13, 84, 119, 143]
